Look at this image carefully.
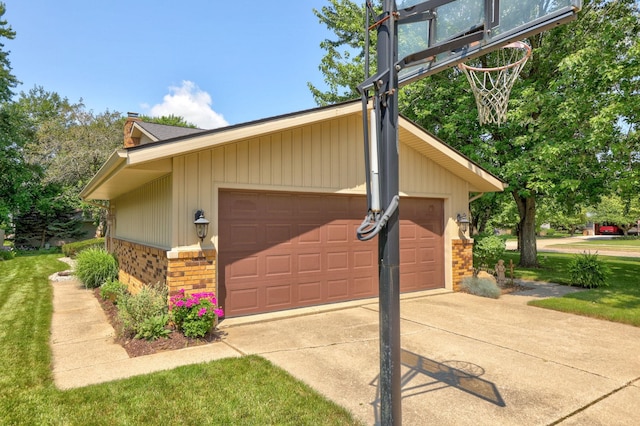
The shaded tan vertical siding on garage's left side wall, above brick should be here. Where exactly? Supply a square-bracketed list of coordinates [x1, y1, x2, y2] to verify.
[114, 175, 172, 247]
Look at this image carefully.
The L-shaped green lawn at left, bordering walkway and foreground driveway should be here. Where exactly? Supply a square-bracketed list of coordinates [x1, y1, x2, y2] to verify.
[0, 254, 358, 425]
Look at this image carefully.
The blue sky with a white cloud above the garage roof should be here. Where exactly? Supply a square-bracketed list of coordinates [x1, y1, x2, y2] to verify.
[3, 0, 333, 128]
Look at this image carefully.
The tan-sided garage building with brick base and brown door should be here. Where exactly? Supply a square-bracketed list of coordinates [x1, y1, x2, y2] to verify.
[81, 102, 503, 317]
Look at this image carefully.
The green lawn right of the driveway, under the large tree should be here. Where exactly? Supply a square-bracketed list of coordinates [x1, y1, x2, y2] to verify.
[506, 253, 640, 327]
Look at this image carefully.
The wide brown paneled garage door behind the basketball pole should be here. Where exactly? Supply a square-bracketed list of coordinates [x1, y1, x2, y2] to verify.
[218, 191, 444, 317]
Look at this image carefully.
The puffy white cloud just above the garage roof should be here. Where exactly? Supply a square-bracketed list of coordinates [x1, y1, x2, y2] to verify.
[149, 80, 229, 129]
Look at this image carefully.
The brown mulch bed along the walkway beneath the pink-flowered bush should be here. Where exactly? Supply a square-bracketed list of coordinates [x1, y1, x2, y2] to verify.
[93, 288, 223, 358]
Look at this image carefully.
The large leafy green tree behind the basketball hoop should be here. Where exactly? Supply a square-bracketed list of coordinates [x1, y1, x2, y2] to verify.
[316, 0, 640, 266]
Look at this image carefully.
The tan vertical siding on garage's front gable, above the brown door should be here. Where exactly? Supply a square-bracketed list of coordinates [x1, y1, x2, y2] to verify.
[173, 114, 468, 246]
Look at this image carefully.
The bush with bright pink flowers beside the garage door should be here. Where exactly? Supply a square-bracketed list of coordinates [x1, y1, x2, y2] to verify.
[169, 289, 224, 337]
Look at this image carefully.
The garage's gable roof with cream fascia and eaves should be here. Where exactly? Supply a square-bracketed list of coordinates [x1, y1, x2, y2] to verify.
[80, 101, 505, 200]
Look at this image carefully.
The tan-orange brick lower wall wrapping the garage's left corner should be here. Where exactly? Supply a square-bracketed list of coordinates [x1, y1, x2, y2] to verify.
[112, 238, 216, 297]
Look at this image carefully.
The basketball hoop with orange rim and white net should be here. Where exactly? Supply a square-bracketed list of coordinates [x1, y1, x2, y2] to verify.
[458, 41, 531, 125]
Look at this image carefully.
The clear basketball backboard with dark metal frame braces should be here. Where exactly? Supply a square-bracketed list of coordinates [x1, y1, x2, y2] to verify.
[396, 0, 582, 86]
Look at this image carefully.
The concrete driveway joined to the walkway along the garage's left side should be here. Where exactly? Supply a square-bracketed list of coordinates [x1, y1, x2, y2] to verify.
[51, 272, 640, 426]
